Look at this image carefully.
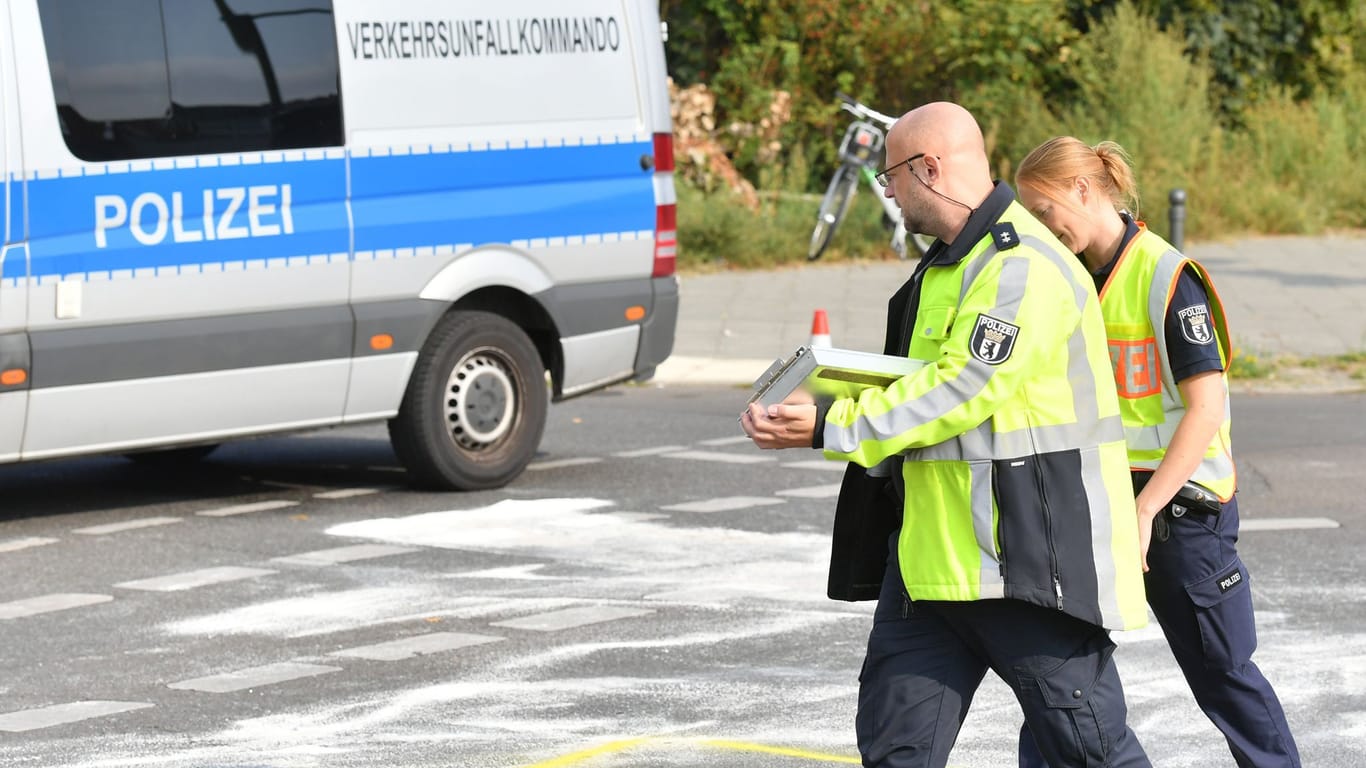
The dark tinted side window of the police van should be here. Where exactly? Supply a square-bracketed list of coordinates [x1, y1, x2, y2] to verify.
[38, 0, 343, 161]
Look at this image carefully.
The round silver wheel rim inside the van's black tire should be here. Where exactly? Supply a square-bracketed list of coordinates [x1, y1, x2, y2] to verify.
[445, 348, 516, 451]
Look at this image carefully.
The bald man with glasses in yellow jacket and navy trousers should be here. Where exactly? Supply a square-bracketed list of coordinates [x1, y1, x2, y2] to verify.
[740, 102, 1149, 768]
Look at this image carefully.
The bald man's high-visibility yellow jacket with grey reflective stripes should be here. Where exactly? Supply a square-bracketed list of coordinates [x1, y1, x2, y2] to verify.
[820, 183, 1147, 629]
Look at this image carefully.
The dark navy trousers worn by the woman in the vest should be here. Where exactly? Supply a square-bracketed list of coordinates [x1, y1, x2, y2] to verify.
[1020, 497, 1300, 768]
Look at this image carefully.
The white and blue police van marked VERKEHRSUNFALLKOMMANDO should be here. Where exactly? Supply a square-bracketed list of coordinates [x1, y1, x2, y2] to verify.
[0, 0, 678, 489]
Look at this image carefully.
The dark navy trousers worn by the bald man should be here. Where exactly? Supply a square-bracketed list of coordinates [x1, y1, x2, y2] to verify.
[855, 540, 1152, 768]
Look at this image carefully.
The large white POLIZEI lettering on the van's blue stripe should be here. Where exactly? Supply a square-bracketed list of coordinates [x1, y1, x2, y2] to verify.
[94, 184, 294, 247]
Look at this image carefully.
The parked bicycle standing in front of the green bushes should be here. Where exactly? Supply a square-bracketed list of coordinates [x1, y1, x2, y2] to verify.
[806, 93, 934, 261]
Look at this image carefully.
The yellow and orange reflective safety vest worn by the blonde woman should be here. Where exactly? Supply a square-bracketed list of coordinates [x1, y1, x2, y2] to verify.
[1100, 224, 1236, 502]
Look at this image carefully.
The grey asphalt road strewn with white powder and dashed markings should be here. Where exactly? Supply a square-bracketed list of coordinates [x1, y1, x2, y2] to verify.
[0, 385, 1366, 768]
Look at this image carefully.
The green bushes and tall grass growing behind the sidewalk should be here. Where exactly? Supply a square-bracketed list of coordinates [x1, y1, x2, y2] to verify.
[661, 0, 1366, 268]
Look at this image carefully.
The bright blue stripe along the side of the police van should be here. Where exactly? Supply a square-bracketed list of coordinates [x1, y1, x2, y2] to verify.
[25, 142, 654, 277]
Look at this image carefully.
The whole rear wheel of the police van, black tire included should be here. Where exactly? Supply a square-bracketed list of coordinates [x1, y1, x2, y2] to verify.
[389, 310, 548, 491]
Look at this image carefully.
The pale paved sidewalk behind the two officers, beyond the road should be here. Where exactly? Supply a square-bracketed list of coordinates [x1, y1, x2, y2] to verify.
[656, 234, 1366, 384]
